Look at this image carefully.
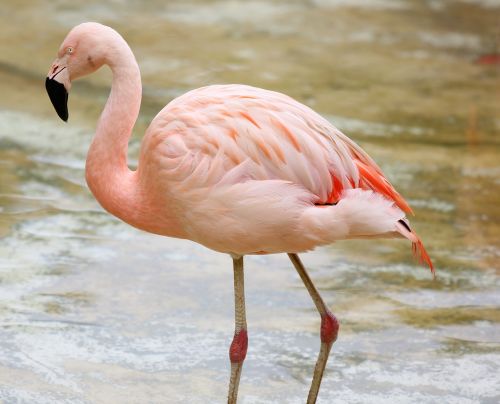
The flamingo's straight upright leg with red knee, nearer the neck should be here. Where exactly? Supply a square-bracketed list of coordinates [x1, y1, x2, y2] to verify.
[227, 257, 248, 404]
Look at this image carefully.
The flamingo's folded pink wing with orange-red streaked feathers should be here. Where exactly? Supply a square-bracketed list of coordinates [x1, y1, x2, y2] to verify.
[149, 85, 411, 212]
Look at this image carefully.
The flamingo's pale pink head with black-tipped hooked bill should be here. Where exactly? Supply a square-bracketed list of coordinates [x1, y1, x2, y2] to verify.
[45, 22, 112, 121]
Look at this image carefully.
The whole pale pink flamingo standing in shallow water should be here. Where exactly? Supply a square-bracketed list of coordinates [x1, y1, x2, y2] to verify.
[46, 22, 434, 404]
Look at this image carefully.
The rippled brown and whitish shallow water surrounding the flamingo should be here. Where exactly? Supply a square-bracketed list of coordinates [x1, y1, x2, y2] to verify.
[0, 0, 500, 403]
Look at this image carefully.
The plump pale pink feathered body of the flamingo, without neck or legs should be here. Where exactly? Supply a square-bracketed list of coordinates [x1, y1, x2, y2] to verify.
[131, 85, 420, 255]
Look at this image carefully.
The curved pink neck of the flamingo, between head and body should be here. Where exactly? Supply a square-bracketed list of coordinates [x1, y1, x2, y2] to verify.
[85, 37, 142, 225]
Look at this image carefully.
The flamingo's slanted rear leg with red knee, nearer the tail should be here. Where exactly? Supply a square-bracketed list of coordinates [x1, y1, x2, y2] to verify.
[288, 254, 339, 404]
